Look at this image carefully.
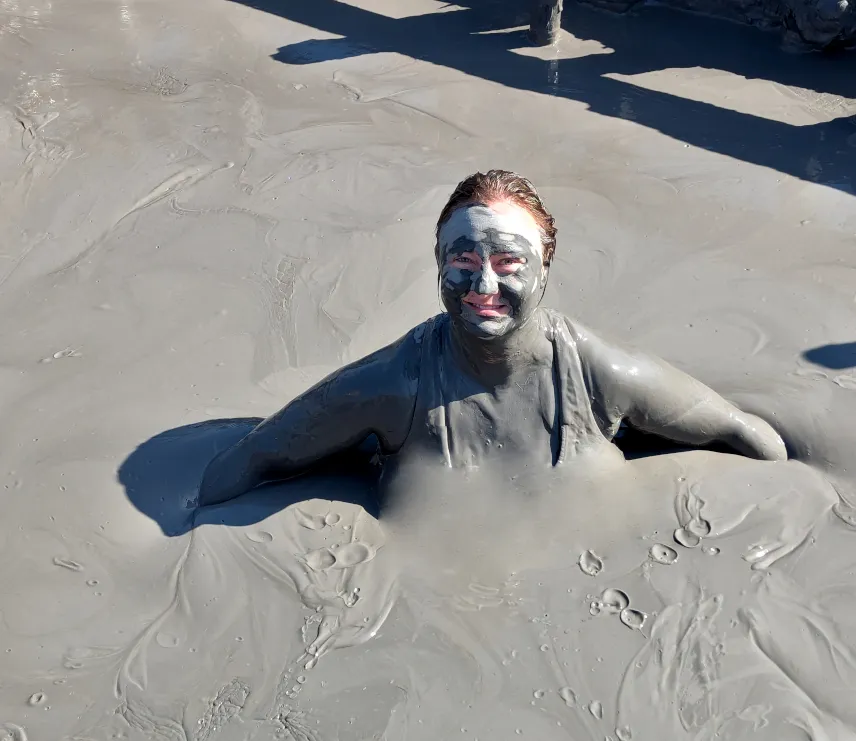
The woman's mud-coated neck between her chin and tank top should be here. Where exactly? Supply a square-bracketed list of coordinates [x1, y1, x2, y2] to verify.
[449, 312, 549, 386]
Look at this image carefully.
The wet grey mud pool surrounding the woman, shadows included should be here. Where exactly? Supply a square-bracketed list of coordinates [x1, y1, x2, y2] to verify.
[0, 0, 856, 741]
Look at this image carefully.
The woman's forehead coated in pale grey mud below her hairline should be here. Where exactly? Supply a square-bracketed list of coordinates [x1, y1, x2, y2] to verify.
[438, 205, 541, 256]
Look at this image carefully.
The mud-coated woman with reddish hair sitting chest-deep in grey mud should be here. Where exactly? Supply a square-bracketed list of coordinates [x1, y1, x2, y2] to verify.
[199, 170, 787, 505]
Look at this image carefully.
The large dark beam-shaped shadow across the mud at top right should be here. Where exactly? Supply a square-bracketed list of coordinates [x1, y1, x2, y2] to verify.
[232, 0, 856, 195]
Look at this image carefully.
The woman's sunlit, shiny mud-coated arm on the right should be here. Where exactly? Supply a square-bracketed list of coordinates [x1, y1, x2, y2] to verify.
[575, 325, 788, 461]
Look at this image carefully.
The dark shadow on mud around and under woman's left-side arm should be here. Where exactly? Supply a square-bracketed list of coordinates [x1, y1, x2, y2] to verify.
[118, 417, 380, 537]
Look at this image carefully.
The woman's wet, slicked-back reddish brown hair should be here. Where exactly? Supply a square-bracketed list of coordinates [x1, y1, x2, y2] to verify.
[435, 170, 556, 265]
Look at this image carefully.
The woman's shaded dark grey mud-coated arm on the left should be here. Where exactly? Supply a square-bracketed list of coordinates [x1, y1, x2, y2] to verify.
[198, 327, 422, 506]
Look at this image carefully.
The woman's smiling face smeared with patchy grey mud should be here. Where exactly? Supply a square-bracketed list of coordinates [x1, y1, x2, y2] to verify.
[437, 203, 547, 339]
